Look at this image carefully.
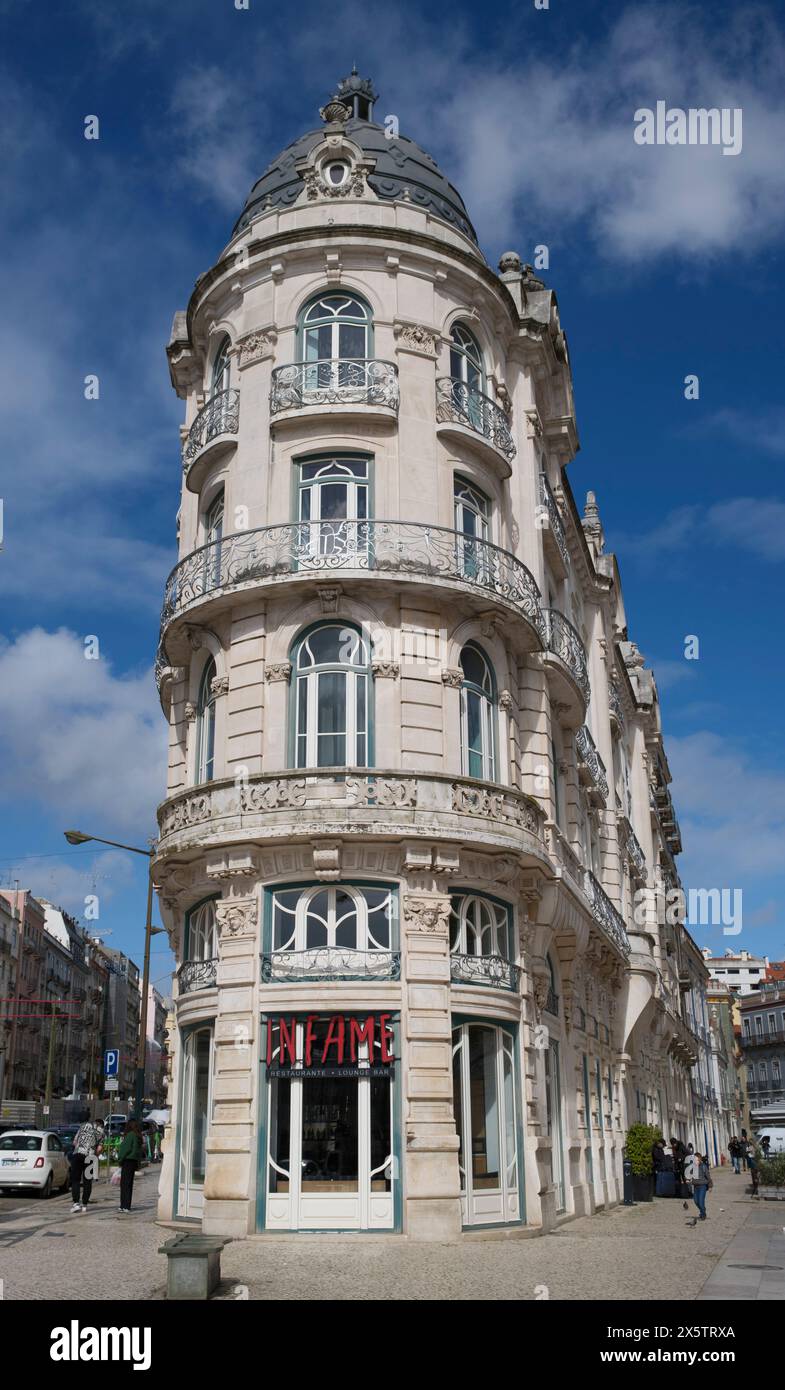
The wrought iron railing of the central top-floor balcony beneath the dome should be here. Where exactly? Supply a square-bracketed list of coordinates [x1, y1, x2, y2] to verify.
[270, 357, 400, 416]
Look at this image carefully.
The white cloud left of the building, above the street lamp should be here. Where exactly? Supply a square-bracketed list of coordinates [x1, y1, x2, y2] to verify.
[0, 628, 167, 845]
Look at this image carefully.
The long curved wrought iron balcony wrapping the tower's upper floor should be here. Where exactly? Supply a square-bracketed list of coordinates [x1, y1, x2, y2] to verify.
[158, 521, 541, 666]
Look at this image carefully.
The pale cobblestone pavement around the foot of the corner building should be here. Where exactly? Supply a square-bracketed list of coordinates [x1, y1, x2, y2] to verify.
[0, 1169, 785, 1301]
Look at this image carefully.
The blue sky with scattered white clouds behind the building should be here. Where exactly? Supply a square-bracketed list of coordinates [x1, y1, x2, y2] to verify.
[0, 0, 785, 988]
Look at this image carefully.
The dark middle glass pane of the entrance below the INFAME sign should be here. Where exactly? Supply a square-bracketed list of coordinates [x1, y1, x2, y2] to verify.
[301, 1067, 358, 1195]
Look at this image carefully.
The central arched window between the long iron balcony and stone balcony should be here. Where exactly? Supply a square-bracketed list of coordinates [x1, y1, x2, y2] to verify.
[293, 623, 371, 767]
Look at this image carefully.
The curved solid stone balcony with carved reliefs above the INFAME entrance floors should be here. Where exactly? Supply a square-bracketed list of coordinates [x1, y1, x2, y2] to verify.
[151, 767, 549, 867]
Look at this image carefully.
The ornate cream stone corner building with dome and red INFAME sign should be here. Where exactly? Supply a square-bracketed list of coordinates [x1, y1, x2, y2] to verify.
[154, 74, 722, 1240]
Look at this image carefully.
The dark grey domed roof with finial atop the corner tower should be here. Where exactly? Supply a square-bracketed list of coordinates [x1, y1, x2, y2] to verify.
[232, 71, 477, 243]
